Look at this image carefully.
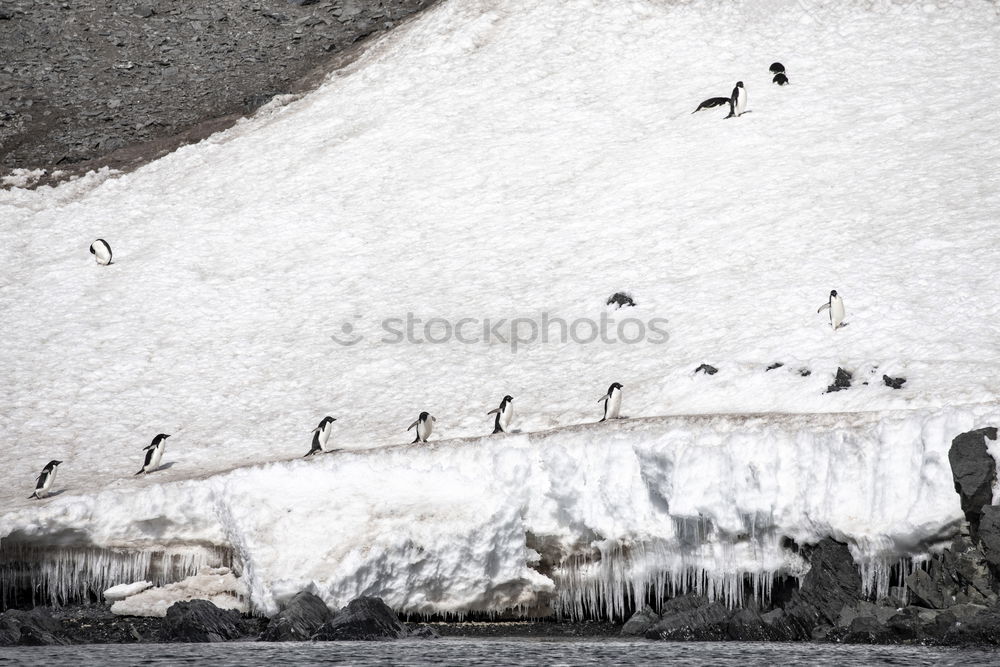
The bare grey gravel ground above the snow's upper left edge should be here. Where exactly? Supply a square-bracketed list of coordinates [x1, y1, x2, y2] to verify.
[0, 0, 436, 174]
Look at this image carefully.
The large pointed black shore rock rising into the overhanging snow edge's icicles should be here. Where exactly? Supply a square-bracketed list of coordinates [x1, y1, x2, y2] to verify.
[785, 538, 861, 639]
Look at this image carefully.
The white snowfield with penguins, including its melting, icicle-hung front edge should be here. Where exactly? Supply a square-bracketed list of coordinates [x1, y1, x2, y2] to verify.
[0, 0, 1000, 613]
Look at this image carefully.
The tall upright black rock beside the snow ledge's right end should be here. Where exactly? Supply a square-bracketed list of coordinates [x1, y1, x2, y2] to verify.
[948, 427, 997, 538]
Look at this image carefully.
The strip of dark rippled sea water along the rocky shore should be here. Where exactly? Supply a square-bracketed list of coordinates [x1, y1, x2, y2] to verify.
[0, 638, 1000, 667]
